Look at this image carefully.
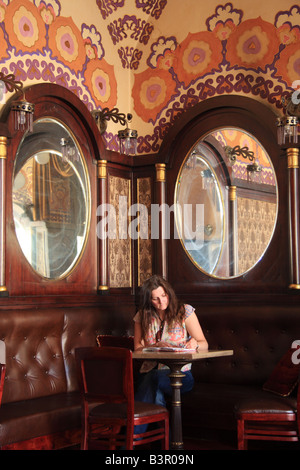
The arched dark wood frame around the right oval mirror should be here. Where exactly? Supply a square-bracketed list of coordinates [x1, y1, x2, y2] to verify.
[156, 96, 299, 295]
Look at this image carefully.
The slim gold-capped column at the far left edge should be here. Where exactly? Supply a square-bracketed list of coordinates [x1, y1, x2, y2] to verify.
[0, 136, 8, 295]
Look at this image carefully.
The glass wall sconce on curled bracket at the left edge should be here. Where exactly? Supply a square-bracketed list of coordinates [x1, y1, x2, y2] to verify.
[0, 72, 34, 132]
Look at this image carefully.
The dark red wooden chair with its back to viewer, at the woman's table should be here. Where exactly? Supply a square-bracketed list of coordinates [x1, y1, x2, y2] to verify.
[75, 347, 169, 450]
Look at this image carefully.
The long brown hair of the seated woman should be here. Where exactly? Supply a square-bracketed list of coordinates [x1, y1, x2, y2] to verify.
[139, 275, 185, 339]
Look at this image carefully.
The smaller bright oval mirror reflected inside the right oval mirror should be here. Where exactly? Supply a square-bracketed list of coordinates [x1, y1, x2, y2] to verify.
[175, 152, 224, 274]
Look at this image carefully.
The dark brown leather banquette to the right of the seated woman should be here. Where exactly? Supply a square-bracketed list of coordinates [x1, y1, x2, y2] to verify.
[193, 304, 300, 386]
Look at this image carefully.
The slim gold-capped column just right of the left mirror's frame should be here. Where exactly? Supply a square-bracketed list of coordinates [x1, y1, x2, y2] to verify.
[97, 160, 109, 294]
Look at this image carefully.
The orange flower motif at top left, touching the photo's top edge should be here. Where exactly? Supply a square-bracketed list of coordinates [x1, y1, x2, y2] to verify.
[5, 0, 46, 52]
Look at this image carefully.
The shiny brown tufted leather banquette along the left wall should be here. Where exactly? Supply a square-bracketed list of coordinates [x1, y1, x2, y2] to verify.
[0, 307, 127, 446]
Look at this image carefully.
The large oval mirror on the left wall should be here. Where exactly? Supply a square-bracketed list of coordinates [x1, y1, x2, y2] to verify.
[13, 118, 90, 279]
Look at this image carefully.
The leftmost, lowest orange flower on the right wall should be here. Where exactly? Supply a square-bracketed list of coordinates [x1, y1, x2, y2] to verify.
[132, 69, 176, 122]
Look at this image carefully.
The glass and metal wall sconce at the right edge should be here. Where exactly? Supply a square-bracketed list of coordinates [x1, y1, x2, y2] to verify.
[277, 91, 300, 145]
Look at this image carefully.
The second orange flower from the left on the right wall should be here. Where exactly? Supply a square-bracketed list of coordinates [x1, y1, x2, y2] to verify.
[175, 31, 222, 86]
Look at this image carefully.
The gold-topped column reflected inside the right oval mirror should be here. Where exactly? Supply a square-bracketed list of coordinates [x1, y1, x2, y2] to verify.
[229, 186, 238, 276]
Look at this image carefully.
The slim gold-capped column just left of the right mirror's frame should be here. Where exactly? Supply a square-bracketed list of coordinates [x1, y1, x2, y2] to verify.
[155, 163, 167, 278]
